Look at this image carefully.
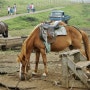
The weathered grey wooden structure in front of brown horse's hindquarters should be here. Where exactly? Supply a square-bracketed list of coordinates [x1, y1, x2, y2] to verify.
[60, 50, 90, 88]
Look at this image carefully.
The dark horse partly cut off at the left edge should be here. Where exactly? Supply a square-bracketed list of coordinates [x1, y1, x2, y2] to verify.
[0, 22, 8, 37]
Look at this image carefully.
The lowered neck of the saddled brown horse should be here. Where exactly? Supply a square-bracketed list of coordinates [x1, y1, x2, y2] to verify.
[19, 25, 38, 60]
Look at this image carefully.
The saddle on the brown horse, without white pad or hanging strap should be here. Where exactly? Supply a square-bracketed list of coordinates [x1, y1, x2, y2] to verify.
[40, 21, 60, 43]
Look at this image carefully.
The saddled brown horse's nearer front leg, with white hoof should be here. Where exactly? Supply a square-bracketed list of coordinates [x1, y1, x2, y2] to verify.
[40, 49, 48, 77]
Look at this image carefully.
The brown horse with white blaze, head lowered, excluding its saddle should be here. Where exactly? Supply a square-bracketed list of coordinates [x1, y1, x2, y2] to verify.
[17, 22, 90, 80]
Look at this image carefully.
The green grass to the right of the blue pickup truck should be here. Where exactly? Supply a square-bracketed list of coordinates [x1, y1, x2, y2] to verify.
[63, 4, 90, 28]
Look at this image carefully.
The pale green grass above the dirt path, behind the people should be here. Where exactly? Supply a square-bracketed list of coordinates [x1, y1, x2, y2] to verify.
[0, 0, 69, 16]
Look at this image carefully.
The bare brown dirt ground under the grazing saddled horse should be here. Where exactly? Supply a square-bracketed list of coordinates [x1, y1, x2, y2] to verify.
[0, 50, 87, 90]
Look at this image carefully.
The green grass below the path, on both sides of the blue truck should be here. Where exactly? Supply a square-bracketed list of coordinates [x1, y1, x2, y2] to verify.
[1, 4, 90, 36]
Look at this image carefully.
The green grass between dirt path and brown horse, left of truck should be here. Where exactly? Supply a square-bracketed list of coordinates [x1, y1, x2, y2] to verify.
[5, 12, 49, 36]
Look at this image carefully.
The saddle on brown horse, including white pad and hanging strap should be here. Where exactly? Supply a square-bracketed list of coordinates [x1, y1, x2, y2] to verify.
[40, 21, 67, 52]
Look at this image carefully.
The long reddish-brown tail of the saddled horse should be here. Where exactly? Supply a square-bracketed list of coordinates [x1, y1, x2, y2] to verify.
[80, 30, 90, 60]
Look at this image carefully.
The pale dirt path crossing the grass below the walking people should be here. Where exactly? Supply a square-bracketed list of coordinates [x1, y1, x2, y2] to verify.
[0, 7, 64, 21]
